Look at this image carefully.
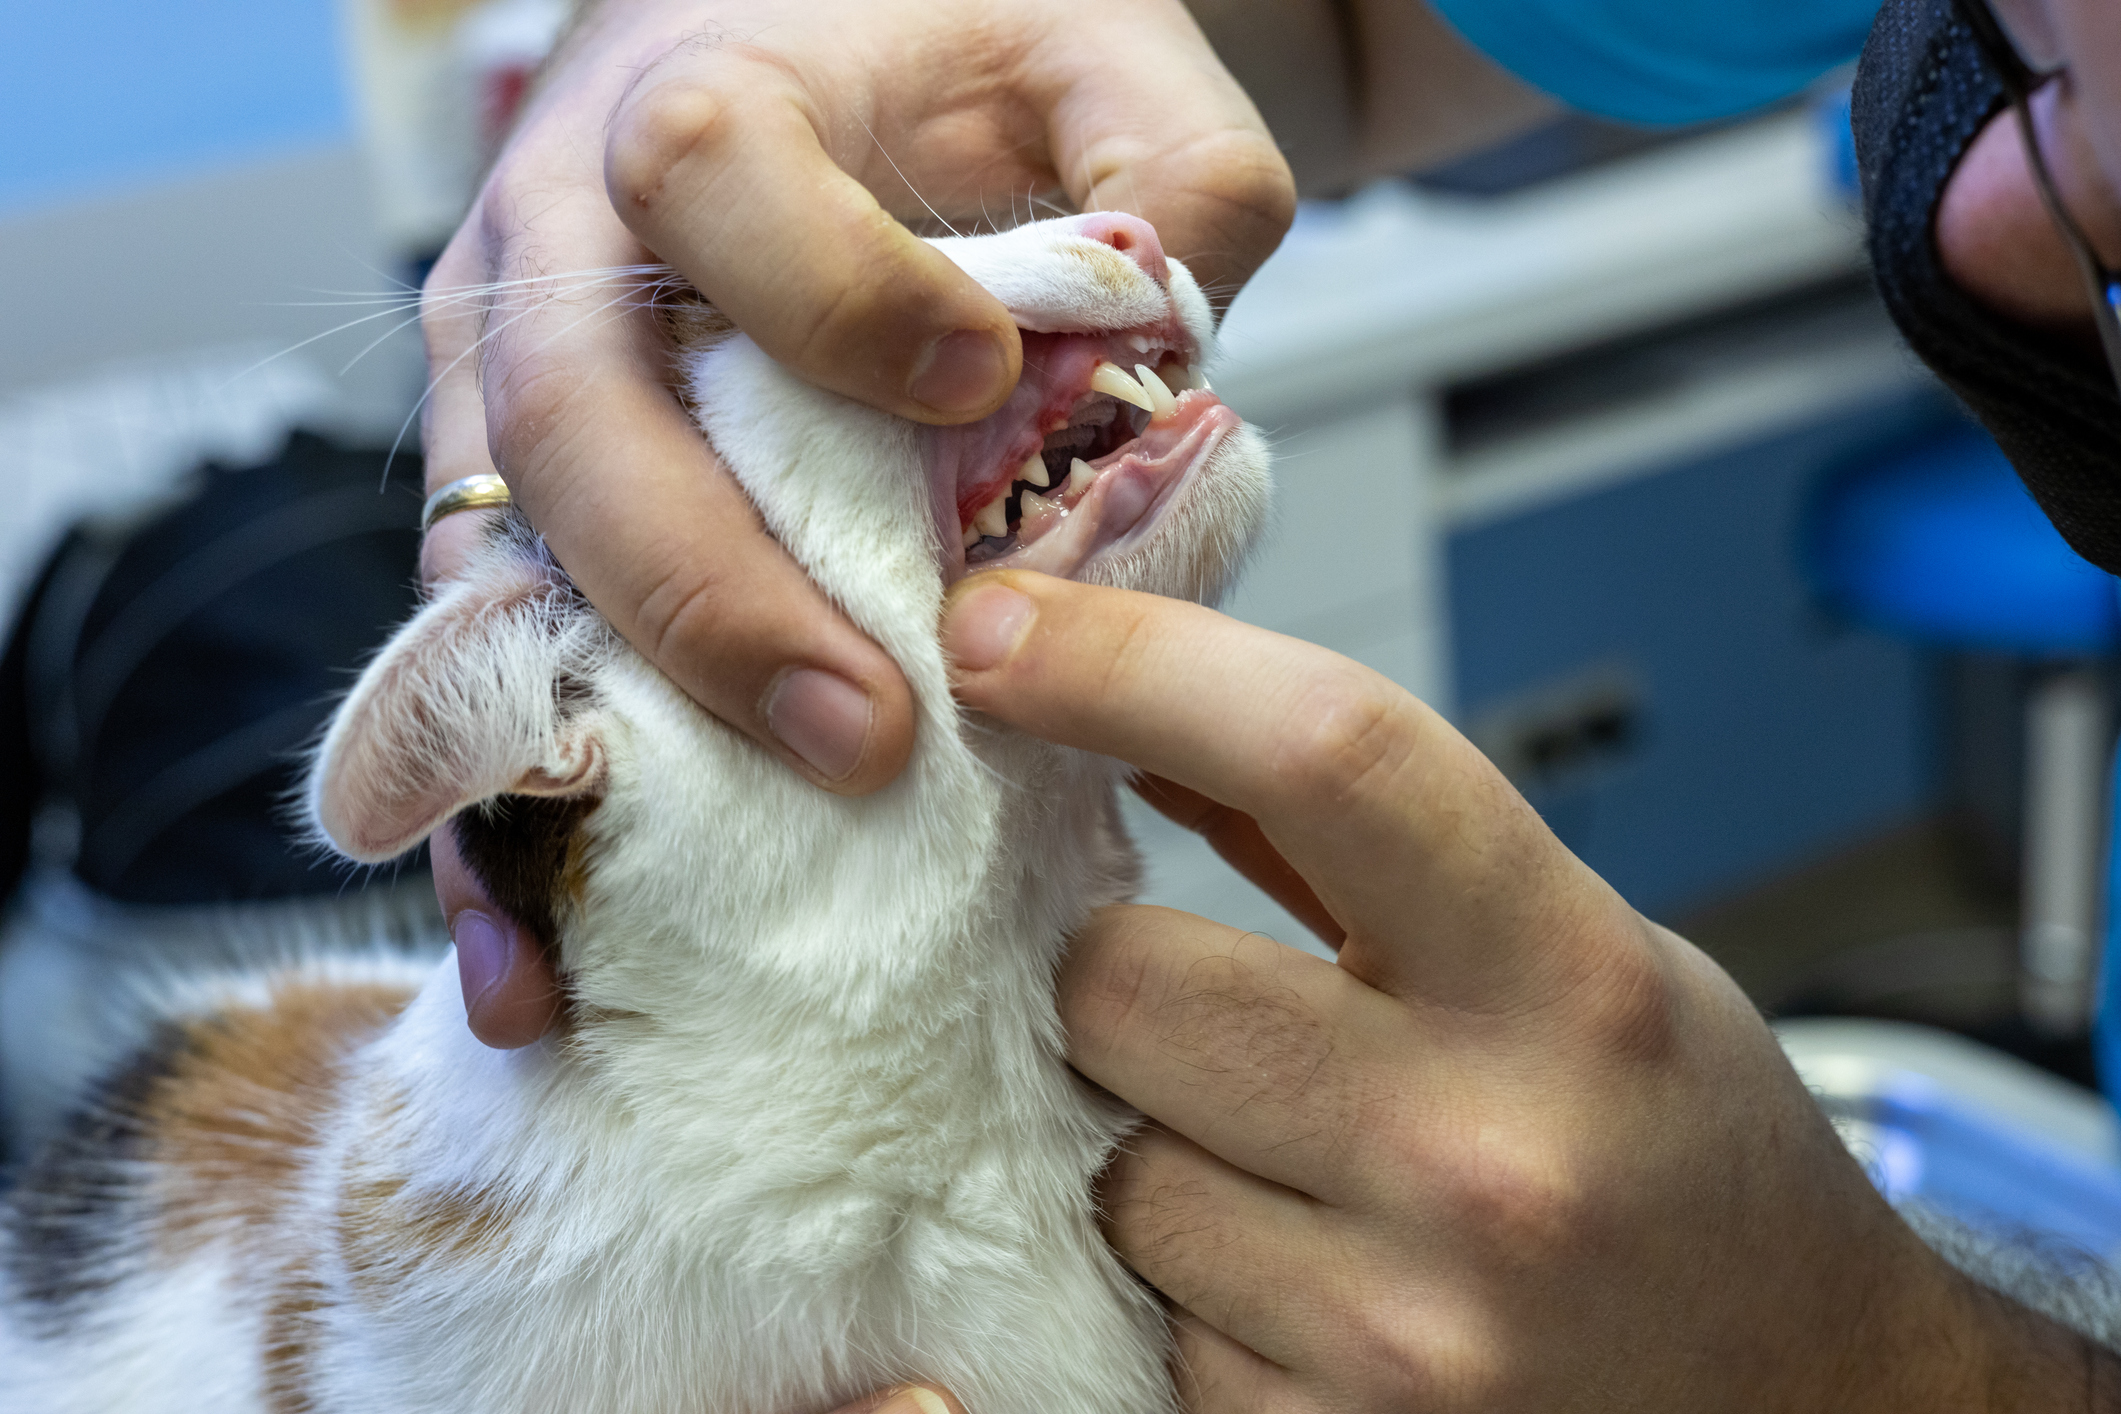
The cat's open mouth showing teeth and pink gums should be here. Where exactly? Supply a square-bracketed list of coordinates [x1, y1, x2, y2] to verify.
[927, 329, 1239, 579]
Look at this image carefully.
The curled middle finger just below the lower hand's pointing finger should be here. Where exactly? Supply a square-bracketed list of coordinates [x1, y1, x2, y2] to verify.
[1056, 905, 1415, 1202]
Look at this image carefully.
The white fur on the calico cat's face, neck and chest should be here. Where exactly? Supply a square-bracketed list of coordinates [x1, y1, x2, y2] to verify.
[0, 223, 1264, 1414]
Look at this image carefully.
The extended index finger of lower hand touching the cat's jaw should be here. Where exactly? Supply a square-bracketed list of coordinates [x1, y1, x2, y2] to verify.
[944, 570, 1611, 1011]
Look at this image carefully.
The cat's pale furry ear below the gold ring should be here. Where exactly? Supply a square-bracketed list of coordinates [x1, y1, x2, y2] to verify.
[308, 555, 604, 863]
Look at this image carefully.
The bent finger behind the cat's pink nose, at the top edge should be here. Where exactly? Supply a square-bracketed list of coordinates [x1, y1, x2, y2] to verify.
[1035, 0, 1296, 305]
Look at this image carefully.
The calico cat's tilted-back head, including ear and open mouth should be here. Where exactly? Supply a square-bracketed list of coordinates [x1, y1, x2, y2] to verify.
[310, 214, 1268, 996]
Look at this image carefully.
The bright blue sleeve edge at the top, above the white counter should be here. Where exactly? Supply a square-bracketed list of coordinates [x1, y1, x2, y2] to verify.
[1430, 0, 1877, 123]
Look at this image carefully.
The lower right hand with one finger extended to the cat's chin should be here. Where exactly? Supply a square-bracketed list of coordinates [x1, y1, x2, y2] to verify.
[944, 572, 2121, 1412]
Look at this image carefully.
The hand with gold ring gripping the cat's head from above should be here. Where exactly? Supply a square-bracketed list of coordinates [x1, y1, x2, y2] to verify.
[422, 0, 1294, 1045]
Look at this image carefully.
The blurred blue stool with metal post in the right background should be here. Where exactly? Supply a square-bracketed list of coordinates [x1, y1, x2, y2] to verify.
[1805, 428, 2121, 1059]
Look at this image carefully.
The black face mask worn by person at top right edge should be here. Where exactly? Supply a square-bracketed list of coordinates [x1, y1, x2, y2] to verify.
[1854, 0, 2121, 572]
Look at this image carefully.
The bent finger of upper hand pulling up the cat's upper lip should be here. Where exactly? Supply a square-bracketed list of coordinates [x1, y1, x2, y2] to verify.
[604, 45, 1022, 422]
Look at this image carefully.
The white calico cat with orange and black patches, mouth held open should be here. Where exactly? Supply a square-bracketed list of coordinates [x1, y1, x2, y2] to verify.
[0, 214, 1268, 1414]
